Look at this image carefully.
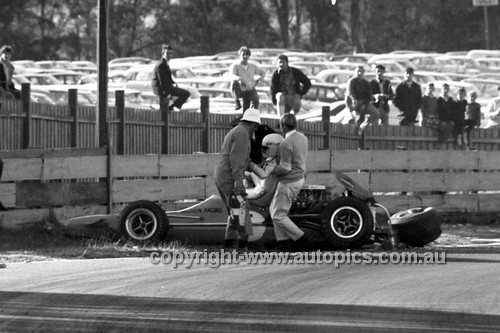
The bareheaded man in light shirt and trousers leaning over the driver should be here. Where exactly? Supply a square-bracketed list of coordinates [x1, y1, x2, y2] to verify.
[269, 113, 310, 251]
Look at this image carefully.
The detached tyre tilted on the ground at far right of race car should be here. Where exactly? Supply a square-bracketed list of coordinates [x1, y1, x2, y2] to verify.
[391, 207, 441, 247]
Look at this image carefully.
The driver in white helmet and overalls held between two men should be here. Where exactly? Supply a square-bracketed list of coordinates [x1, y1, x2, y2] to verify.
[246, 133, 283, 199]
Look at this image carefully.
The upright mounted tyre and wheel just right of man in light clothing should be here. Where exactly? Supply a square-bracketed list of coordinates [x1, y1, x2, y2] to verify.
[321, 197, 373, 249]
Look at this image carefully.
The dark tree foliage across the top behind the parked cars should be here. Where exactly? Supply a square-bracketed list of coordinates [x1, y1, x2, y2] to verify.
[0, 0, 500, 60]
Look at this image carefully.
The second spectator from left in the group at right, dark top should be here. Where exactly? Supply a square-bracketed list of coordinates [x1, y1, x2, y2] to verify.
[370, 64, 394, 125]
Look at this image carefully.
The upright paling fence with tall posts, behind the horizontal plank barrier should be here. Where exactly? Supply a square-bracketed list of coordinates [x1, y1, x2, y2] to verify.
[0, 89, 500, 155]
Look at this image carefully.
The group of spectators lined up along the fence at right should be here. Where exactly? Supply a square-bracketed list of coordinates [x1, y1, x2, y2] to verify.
[345, 65, 492, 149]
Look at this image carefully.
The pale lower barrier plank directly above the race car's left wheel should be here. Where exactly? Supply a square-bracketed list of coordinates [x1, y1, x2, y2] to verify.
[113, 178, 207, 203]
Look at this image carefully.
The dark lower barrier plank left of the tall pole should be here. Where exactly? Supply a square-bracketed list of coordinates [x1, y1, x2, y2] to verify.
[16, 182, 107, 208]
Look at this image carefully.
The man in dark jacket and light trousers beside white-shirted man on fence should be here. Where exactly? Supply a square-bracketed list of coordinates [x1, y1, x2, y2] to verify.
[270, 54, 311, 116]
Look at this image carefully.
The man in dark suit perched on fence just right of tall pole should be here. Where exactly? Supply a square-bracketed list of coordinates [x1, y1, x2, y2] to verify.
[151, 44, 190, 111]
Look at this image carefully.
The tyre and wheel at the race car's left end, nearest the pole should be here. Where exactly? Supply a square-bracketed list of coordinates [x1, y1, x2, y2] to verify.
[120, 200, 169, 243]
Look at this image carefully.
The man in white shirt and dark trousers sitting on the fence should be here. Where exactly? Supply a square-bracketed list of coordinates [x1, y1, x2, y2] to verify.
[229, 46, 266, 112]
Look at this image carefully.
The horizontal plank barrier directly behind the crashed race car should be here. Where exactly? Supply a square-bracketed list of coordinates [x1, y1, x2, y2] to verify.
[0, 148, 500, 226]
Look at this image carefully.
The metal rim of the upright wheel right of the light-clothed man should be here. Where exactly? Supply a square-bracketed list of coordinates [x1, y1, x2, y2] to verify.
[330, 206, 363, 239]
